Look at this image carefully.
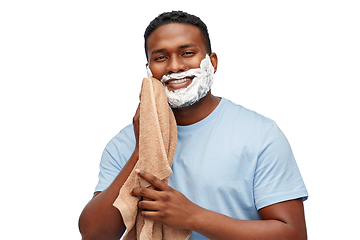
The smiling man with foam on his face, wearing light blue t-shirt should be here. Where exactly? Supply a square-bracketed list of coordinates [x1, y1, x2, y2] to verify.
[79, 12, 307, 240]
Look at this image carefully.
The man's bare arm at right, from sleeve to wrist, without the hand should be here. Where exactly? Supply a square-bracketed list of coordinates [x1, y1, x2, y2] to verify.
[194, 199, 307, 240]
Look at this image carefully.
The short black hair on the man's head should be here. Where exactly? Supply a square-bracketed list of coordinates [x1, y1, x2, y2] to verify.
[144, 11, 211, 58]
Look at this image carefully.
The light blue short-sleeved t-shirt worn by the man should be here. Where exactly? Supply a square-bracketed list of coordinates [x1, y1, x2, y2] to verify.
[95, 98, 308, 240]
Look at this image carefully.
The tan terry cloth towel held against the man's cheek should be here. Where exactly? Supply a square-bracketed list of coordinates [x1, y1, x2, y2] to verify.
[113, 78, 192, 240]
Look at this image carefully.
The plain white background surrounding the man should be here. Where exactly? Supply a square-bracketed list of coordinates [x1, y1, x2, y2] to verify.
[0, 0, 360, 240]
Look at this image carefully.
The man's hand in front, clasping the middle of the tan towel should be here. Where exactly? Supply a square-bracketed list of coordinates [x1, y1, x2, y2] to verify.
[130, 170, 201, 229]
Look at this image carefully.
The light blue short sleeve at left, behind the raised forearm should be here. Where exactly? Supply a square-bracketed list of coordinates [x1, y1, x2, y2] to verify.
[95, 125, 135, 192]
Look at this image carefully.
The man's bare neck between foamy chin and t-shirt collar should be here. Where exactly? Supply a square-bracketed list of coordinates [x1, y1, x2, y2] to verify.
[172, 91, 220, 126]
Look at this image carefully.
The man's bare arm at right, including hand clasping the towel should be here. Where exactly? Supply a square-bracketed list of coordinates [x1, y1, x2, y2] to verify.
[131, 171, 307, 240]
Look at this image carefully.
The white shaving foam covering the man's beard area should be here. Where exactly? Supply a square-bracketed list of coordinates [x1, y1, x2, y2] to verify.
[146, 54, 214, 108]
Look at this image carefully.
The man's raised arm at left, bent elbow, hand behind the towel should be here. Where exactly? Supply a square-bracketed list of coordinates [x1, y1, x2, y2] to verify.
[79, 108, 139, 240]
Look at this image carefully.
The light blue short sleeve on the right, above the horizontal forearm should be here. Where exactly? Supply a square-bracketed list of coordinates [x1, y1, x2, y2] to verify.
[254, 122, 308, 210]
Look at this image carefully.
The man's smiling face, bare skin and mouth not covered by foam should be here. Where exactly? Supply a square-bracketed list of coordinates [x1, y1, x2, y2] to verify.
[147, 23, 216, 91]
